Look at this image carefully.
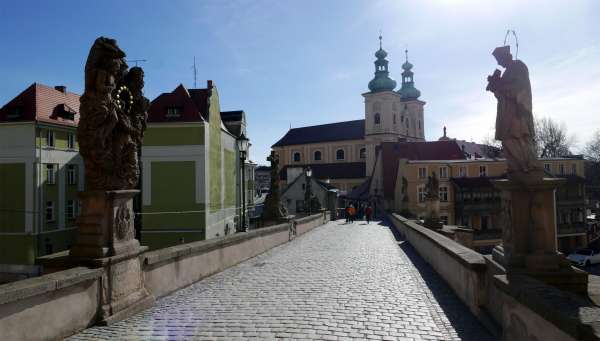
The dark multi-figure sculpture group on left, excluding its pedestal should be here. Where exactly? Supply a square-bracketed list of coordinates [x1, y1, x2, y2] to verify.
[77, 37, 150, 191]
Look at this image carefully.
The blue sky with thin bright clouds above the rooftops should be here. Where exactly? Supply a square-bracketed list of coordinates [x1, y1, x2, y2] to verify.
[0, 0, 600, 164]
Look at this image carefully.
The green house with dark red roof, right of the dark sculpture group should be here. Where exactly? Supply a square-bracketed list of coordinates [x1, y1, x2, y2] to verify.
[141, 81, 251, 248]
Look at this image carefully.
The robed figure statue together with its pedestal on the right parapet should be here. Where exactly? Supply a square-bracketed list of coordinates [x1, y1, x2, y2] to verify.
[486, 46, 587, 292]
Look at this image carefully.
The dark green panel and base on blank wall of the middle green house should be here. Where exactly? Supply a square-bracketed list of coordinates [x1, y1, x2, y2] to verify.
[142, 161, 205, 232]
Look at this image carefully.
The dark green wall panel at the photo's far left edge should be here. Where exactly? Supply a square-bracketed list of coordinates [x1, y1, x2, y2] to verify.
[0, 163, 25, 232]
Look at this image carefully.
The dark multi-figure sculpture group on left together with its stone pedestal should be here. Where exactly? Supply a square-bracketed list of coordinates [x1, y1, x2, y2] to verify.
[70, 37, 154, 323]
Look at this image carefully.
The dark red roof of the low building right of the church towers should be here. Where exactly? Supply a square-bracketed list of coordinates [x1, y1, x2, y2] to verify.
[381, 141, 465, 199]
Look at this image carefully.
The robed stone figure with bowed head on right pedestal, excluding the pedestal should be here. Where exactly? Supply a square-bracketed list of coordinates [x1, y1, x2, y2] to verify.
[486, 46, 543, 182]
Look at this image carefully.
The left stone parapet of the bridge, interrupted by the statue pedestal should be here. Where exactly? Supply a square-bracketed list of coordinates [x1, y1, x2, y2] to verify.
[0, 211, 330, 340]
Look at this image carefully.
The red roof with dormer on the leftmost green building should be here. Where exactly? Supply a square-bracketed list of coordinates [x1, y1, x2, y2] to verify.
[0, 83, 80, 127]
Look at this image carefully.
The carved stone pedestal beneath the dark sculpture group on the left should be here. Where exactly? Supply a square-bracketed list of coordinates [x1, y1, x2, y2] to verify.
[69, 190, 154, 324]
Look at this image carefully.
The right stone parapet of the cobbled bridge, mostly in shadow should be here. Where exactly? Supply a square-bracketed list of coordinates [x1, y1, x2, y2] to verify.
[389, 214, 600, 341]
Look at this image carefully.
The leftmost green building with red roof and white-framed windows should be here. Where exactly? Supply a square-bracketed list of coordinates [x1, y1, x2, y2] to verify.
[0, 83, 83, 283]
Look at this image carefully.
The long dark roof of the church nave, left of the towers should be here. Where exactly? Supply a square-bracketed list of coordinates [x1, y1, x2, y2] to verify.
[273, 119, 365, 147]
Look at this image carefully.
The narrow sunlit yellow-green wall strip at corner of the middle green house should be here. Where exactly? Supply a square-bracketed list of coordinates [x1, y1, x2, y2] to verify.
[208, 88, 223, 213]
